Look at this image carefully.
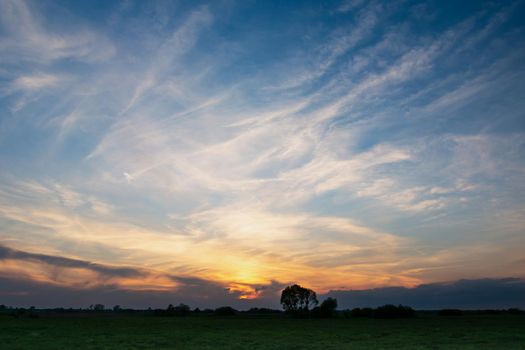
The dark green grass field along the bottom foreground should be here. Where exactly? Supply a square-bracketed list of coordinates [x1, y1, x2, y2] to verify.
[0, 315, 525, 350]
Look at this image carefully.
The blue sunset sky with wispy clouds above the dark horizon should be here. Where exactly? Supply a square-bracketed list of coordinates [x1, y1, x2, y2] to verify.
[0, 0, 525, 306]
